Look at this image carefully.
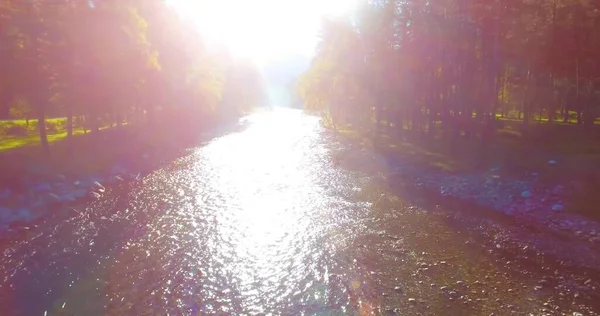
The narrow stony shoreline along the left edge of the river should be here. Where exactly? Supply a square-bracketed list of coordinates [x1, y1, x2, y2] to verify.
[0, 121, 244, 239]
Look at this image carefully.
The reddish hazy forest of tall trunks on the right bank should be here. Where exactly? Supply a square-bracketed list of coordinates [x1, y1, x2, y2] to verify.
[296, 0, 600, 173]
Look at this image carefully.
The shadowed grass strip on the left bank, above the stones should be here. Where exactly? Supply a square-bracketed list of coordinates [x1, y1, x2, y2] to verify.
[0, 120, 250, 187]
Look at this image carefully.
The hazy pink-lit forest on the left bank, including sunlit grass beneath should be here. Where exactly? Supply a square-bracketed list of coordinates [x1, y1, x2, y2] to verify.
[0, 0, 265, 173]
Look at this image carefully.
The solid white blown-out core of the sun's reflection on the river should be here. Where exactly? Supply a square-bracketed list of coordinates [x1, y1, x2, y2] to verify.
[200, 110, 344, 312]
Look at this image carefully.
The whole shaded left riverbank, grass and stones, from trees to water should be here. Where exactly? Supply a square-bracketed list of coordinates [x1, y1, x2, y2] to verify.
[0, 117, 244, 235]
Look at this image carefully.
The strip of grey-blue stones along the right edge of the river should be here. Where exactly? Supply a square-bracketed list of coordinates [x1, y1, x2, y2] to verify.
[387, 154, 600, 246]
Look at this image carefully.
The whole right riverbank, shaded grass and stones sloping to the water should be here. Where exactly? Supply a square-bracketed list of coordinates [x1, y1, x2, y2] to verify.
[338, 124, 600, 247]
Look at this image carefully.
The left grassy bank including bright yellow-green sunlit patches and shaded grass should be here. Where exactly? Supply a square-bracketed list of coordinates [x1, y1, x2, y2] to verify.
[0, 115, 220, 189]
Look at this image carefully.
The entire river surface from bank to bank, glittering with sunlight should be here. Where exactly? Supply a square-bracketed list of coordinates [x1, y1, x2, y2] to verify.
[0, 109, 596, 315]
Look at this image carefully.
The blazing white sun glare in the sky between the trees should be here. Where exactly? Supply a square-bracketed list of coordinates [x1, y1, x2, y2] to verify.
[167, 0, 358, 63]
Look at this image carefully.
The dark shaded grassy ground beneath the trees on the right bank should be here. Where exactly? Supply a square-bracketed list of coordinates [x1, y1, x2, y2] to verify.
[338, 124, 600, 220]
